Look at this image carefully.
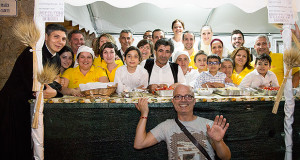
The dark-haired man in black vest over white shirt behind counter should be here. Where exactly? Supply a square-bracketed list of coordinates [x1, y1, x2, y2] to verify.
[144, 38, 185, 92]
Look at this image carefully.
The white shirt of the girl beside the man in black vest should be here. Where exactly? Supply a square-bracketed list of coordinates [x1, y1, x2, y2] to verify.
[114, 65, 149, 93]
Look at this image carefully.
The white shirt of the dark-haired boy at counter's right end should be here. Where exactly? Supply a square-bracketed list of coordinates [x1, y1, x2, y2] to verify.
[239, 69, 279, 88]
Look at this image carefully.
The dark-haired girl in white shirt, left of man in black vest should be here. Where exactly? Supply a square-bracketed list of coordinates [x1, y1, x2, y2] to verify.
[115, 46, 148, 93]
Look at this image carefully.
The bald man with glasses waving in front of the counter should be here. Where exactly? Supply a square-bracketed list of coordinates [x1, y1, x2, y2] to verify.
[134, 84, 231, 160]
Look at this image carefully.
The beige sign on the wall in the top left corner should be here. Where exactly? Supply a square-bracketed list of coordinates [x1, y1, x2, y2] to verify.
[0, 0, 17, 16]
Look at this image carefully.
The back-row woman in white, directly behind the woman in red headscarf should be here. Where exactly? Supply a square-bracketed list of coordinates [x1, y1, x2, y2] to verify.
[198, 25, 213, 53]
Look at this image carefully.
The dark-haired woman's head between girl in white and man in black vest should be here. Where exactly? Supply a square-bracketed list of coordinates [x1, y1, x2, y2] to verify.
[137, 39, 154, 61]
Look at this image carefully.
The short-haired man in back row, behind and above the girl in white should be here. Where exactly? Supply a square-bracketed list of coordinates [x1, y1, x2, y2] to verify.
[117, 29, 134, 64]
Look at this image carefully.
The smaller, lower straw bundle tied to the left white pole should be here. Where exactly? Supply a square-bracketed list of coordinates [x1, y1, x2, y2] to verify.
[32, 64, 58, 129]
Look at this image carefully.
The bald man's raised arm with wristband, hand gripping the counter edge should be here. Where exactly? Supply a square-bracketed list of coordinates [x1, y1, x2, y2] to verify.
[134, 98, 157, 149]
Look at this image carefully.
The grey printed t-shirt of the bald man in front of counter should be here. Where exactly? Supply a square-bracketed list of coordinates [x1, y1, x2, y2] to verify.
[150, 117, 215, 160]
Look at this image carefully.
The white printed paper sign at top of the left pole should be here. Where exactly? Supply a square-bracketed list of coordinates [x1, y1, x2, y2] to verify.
[38, 0, 64, 22]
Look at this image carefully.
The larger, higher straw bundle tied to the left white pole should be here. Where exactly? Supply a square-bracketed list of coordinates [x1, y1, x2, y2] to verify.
[12, 18, 40, 92]
